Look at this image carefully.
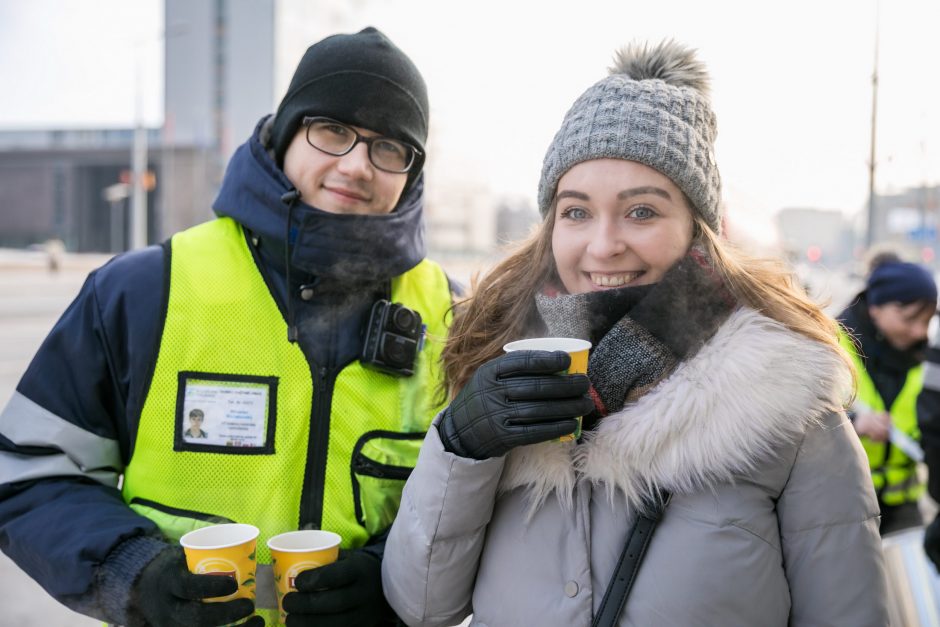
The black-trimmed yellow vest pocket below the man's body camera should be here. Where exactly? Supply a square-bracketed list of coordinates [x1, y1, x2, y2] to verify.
[351, 431, 425, 536]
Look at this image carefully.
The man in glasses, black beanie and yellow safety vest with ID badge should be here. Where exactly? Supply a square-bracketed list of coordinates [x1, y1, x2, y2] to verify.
[0, 28, 458, 627]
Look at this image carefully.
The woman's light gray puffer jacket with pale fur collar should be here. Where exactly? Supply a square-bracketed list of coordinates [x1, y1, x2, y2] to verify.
[382, 309, 888, 627]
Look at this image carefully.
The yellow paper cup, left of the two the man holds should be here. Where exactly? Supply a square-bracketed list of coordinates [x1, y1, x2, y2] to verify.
[180, 523, 259, 602]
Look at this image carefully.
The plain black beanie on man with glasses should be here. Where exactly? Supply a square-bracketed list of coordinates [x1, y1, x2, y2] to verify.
[270, 26, 428, 186]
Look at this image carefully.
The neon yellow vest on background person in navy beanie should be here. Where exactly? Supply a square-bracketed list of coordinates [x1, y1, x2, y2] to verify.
[839, 329, 924, 505]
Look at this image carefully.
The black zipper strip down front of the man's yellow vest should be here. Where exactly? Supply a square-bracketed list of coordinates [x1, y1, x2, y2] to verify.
[297, 366, 337, 529]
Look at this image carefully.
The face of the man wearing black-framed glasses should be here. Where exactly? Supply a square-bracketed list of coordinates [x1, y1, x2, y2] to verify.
[284, 126, 408, 215]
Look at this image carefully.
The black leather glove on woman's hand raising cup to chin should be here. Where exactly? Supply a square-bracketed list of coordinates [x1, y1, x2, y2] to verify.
[439, 351, 594, 459]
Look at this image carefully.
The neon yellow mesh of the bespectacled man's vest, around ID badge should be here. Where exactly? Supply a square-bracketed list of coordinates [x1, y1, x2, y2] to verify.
[123, 219, 450, 563]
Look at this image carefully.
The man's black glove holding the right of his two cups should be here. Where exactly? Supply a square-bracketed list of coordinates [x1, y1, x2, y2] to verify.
[283, 550, 394, 627]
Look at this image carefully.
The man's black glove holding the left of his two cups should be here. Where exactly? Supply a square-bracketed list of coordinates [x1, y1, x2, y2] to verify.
[128, 547, 264, 627]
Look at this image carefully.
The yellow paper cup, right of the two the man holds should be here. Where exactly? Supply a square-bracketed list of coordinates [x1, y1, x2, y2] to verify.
[268, 529, 343, 624]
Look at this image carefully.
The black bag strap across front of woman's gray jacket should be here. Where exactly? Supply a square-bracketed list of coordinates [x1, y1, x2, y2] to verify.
[591, 490, 672, 627]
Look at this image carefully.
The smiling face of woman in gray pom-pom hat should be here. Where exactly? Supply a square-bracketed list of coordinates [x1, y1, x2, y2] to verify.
[552, 159, 693, 294]
